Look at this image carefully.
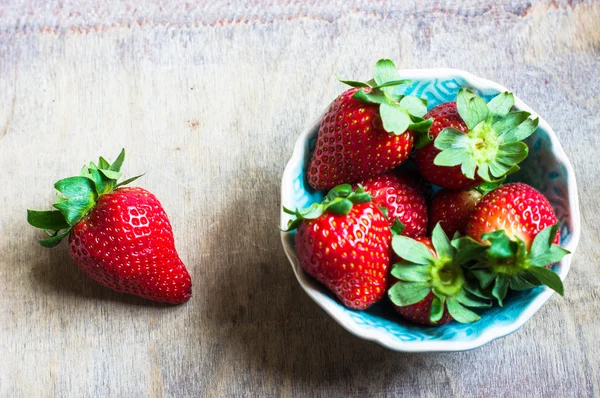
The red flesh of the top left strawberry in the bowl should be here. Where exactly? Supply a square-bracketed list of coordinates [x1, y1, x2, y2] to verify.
[307, 88, 413, 190]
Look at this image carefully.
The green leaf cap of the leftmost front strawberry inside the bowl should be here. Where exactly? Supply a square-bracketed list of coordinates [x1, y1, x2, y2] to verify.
[283, 184, 373, 232]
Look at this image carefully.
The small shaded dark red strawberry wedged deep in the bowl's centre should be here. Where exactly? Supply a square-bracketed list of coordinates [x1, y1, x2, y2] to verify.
[429, 189, 481, 236]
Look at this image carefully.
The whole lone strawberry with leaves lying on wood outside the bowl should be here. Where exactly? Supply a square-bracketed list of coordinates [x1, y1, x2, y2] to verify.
[27, 150, 192, 304]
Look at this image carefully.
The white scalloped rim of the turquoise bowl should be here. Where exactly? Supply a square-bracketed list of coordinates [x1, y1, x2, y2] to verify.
[280, 68, 581, 352]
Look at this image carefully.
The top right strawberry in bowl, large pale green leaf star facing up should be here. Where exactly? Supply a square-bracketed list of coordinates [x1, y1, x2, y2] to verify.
[415, 88, 538, 190]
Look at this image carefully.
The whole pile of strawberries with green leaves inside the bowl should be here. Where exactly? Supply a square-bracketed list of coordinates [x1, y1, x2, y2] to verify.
[284, 59, 568, 325]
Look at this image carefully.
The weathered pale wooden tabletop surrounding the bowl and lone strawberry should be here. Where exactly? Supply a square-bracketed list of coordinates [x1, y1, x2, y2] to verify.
[0, 0, 600, 397]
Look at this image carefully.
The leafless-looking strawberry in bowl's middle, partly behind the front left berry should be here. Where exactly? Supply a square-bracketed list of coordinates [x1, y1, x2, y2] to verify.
[360, 172, 427, 238]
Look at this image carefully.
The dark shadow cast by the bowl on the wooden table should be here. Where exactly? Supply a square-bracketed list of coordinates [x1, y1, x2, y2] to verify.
[200, 168, 444, 392]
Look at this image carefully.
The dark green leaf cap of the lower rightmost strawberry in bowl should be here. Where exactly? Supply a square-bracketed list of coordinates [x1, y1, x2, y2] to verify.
[452, 224, 569, 306]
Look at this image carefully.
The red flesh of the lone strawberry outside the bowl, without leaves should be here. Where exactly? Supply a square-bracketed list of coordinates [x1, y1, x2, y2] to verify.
[69, 187, 192, 304]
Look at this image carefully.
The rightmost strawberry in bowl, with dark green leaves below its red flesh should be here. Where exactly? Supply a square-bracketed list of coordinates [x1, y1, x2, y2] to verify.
[453, 183, 569, 305]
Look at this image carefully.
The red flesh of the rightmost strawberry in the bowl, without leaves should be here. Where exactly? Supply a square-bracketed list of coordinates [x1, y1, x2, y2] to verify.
[466, 182, 560, 249]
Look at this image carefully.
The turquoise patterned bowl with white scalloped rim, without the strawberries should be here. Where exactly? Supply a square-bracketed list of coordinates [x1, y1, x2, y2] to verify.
[281, 69, 581, 352]
